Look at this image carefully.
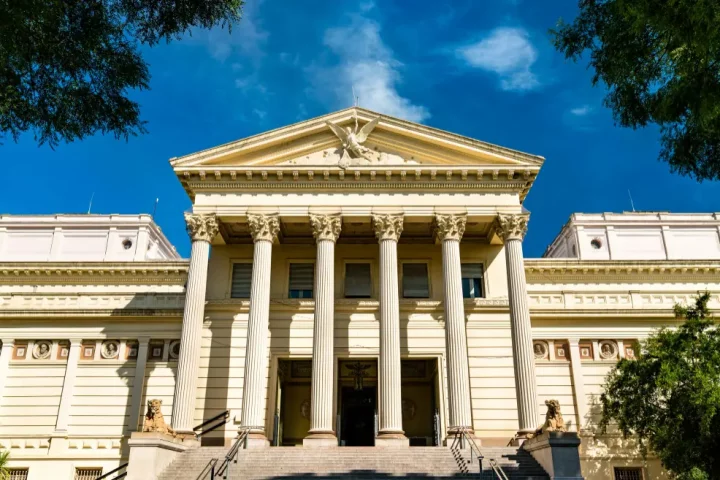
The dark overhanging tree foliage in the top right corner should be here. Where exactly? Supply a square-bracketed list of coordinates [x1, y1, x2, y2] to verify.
[550, 0, 720, 181]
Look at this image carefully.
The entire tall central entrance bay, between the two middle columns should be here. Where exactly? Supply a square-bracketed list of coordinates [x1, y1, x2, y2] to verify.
[338, 358, 377, 447]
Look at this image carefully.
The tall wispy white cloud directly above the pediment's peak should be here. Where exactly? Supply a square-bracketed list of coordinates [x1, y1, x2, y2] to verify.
[309, 17, 430, 122]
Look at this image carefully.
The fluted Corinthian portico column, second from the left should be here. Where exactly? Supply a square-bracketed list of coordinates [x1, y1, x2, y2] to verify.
[240, 215, 280, 447]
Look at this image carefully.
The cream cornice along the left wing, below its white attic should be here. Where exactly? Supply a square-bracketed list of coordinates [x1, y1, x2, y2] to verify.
[0, 261, 189, 285]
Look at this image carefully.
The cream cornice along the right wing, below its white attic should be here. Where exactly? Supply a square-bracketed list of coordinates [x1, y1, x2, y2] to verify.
[525, 259, 720, 284]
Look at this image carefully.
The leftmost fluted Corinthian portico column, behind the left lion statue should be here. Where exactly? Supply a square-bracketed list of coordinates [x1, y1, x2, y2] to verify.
[172, 213, 218, 436]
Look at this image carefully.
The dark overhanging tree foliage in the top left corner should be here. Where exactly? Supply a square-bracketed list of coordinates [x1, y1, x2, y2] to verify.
[0, 0, 243, 146]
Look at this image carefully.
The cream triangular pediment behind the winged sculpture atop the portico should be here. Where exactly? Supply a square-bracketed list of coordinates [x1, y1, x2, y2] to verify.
[170, 107, 544, 171]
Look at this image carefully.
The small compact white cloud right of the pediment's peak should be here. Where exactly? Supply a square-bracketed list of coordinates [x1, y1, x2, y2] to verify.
[456, 27, 540, 91]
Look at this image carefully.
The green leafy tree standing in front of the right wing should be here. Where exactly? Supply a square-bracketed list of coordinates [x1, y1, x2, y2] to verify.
[600, 293, 720, 480]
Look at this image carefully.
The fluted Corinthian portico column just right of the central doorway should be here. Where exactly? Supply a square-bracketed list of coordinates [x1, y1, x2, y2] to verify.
[373, 215, 409, 446]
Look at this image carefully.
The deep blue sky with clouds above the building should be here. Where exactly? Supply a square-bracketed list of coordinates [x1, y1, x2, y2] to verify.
[0, 0, 720, 257]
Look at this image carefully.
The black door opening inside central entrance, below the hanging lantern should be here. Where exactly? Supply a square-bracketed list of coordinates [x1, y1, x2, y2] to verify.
[340, 387, 376, 447]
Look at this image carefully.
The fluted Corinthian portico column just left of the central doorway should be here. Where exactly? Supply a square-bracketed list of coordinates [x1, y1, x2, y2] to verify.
[303, 214, 341, 447]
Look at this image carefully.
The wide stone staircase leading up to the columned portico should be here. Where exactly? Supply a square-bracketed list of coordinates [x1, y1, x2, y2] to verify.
[160, 447, 549, 480]
